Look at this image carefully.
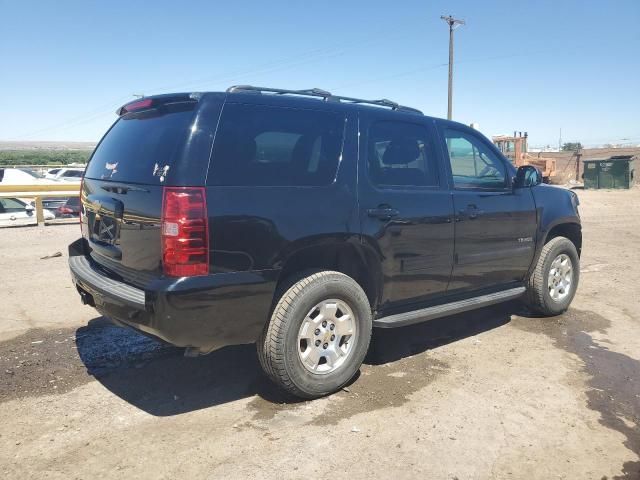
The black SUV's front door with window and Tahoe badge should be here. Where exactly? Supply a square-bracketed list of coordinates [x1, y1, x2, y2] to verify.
[440, 123, 537, 294]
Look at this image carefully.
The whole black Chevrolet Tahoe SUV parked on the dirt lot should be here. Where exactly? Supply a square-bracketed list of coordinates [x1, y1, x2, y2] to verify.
[69, 86, 582, 398]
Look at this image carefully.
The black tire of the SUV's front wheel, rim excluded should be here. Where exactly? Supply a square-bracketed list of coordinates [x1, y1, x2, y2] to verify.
[525, 237, 580, 317]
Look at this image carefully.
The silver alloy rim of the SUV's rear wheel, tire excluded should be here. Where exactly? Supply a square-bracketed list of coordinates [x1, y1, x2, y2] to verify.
[297, 298, 357, 374]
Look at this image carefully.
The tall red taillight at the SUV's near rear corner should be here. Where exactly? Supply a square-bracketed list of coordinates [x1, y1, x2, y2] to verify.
[162, 187, 209, 277]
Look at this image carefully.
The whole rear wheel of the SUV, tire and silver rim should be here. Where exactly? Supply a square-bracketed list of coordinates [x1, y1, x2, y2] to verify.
[257, 271, 371, 398]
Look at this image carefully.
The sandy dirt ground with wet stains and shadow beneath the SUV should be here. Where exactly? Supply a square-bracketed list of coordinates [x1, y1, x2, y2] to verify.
[0, 188, 640, 480]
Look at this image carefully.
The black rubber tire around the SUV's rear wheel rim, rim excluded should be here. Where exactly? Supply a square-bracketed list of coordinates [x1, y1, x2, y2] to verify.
[257, 271, 372, 399]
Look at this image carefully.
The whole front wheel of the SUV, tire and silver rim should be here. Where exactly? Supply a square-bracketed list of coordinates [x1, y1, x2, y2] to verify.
[525, 237, 580, 316]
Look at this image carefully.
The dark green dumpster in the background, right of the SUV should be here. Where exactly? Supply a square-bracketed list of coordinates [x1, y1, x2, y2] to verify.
[582, 155, 637, 189]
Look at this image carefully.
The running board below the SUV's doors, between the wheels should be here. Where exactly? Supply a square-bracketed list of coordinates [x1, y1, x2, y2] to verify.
[373, 287, 526, 328]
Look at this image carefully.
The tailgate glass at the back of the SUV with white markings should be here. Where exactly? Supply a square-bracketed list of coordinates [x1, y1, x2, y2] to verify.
[85, 102, 195, 183]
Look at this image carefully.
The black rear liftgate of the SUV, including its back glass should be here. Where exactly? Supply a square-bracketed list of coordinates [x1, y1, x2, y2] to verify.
[81, 94, 210, 288]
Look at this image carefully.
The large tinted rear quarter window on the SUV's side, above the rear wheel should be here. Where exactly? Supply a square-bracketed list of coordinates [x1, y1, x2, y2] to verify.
[208, 103, 345, 186]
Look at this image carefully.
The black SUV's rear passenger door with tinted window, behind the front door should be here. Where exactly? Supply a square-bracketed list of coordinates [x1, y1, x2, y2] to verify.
[358, 111, 454, 311]
